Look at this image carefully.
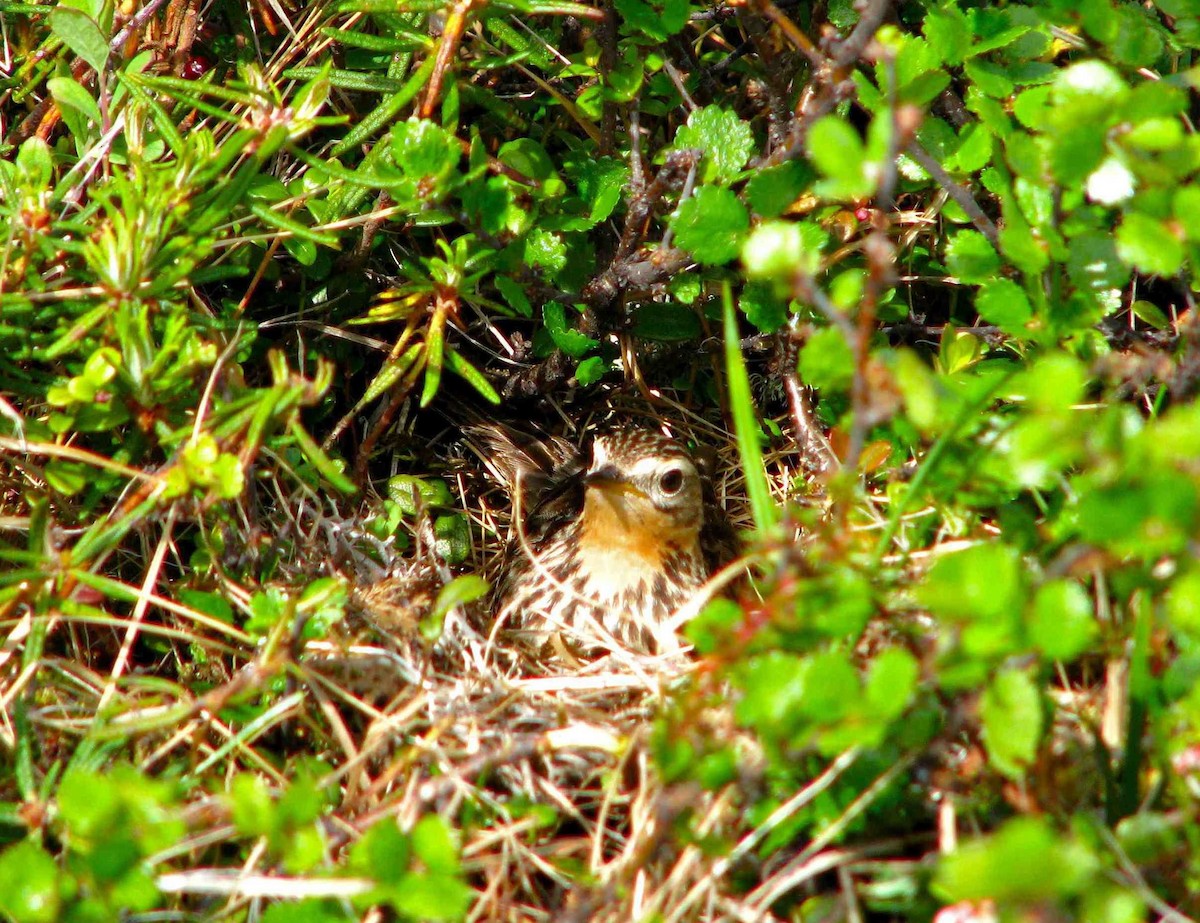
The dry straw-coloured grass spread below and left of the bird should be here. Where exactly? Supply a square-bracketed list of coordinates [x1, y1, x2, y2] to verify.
[0, 393, 825, 921]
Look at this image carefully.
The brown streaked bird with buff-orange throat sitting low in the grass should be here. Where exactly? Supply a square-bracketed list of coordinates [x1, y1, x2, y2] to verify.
[472, 425, 731, 655]
